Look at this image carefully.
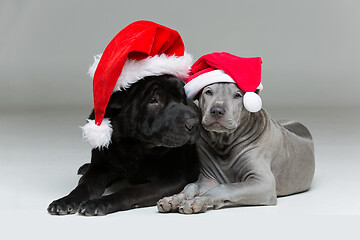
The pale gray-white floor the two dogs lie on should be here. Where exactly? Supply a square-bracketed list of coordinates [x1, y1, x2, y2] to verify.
[0, 107, 360, 239]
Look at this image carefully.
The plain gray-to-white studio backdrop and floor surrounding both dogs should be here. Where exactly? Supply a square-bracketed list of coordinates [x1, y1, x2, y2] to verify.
[0, 0, 360, 240]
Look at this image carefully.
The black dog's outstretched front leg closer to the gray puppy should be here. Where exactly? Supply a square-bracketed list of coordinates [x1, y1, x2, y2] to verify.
[79, 178, 190, 216]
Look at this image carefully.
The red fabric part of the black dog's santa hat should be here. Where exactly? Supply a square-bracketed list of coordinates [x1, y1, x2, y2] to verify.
[93, 21, 185, 125]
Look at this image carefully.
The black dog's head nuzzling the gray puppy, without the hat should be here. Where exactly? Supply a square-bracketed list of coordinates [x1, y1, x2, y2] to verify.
[105, 75, 200, 147]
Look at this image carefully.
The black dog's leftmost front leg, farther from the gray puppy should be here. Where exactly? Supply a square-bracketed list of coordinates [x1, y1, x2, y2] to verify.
[48, 152, 119, 215]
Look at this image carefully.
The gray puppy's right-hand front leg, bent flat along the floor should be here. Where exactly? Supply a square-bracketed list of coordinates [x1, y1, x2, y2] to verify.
[179, 171, 277, 214]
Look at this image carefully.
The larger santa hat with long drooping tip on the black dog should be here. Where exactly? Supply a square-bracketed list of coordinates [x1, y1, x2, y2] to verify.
[82, 21, 192, 148]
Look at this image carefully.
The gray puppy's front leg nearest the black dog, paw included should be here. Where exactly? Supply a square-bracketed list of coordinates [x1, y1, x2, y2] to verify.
[157, 175, 218, 212]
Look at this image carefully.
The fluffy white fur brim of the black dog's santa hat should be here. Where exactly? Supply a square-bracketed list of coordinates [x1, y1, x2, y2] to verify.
[88, 52, 193, 92]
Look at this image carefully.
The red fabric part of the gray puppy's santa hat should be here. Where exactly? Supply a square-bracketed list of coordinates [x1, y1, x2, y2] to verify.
[186, 52, 262, 92]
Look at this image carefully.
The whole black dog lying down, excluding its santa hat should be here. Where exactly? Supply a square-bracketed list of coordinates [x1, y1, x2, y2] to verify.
[48, 75, 199, 215]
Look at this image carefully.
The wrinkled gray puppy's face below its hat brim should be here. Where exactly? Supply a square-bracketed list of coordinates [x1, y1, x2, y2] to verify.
[199, 83, 249, 133]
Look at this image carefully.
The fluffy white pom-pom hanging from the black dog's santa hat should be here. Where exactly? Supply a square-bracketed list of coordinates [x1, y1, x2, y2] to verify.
[81, 118, 113, 149]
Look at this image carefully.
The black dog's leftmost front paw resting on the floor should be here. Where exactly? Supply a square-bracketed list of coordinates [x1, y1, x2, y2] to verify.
[47, 196, 81, 215]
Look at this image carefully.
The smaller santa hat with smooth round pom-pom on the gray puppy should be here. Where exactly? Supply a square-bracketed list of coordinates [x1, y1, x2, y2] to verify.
[185, 52, 263, 112]
